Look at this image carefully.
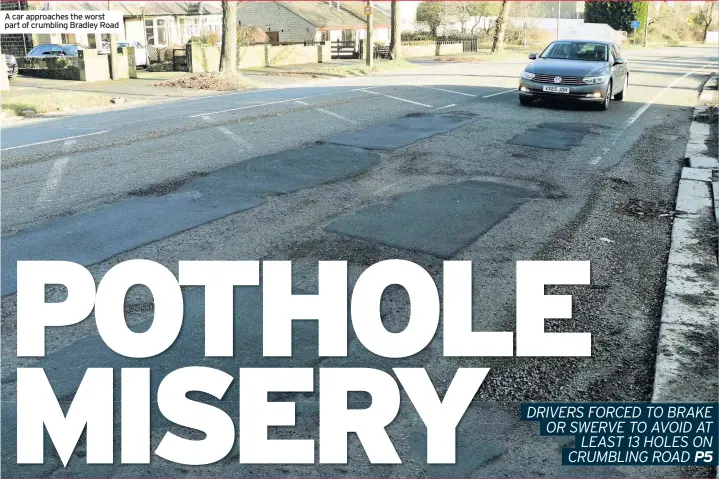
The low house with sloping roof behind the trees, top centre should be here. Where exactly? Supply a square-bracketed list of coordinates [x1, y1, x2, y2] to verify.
[237, 1, 390, 44]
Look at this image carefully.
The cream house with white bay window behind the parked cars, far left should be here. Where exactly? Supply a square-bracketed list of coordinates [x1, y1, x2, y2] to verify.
[2, 1, 222, 56]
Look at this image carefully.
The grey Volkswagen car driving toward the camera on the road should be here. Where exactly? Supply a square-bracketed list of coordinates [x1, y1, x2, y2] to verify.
[519, 40, 629, 110]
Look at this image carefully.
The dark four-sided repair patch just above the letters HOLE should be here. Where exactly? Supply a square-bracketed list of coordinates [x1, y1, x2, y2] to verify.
[325, 181, 538, 258]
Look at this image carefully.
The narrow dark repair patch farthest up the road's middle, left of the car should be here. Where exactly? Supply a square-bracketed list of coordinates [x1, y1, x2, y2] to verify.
[323, 112, 476, 150]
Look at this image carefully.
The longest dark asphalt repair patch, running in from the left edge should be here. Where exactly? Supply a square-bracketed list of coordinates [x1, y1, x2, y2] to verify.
[2, 145, 380, 296]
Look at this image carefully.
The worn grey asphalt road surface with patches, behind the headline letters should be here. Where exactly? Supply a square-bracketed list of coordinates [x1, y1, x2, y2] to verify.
[1, 47, 717, 477]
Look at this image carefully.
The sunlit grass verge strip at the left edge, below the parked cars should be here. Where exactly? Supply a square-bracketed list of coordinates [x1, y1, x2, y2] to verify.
[0, 90, 125, 116]
